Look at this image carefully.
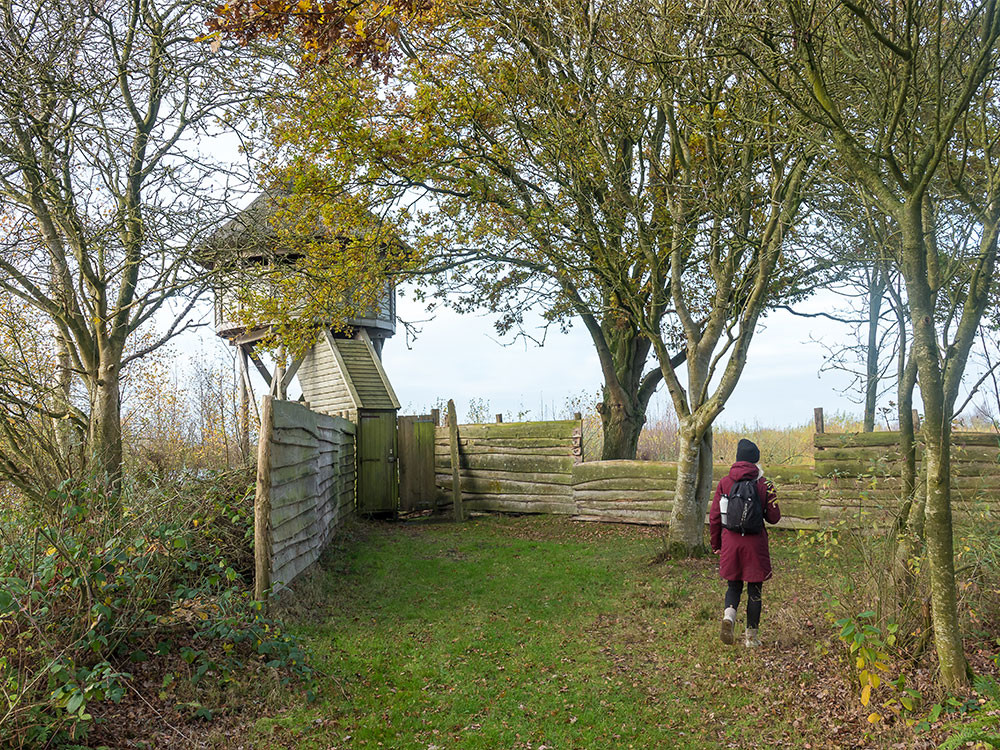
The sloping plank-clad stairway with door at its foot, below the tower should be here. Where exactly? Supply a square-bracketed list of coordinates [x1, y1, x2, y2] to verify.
[298, 328, 399, 515]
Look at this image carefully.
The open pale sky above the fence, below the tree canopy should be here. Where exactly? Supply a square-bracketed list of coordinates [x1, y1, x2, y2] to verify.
[382, 288, 861, 426]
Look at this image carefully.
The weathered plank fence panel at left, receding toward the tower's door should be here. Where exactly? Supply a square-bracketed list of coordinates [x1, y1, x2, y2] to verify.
[254, 396, 356, 599]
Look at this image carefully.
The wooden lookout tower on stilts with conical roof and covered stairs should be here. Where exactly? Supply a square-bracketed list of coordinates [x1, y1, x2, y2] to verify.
[206, 191, 399, 515]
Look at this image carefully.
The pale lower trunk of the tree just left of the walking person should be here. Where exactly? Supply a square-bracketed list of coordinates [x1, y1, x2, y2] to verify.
[667, 418, 711, 557]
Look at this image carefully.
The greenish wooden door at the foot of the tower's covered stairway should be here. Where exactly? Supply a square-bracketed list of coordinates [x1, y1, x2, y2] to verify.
[357, 409, 399, 516]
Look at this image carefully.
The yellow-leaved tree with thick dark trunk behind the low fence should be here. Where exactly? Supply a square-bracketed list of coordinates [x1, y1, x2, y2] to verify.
[248, 1, 812, 484]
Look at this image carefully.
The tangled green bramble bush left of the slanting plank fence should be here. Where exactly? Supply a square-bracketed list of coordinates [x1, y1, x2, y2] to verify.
[0, 471, 315, 748]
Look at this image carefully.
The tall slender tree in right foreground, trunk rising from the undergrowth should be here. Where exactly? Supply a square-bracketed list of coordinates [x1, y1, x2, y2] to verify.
[730, 0, 1000, 687]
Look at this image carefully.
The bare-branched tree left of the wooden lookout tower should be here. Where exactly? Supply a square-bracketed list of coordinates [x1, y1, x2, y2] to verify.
[0, 0, 246, 490]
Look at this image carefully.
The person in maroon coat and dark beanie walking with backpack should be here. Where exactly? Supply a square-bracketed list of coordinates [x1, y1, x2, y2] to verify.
[708, 439, 781, 648]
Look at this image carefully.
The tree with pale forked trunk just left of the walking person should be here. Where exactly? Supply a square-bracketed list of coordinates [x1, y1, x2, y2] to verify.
[630, 17, 817, 554]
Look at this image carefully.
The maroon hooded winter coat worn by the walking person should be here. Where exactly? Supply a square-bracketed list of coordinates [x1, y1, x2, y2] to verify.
[708, 461, 781, 582]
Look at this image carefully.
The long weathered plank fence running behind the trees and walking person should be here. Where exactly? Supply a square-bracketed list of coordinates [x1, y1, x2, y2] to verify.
[434, 420, 1000, 528]
